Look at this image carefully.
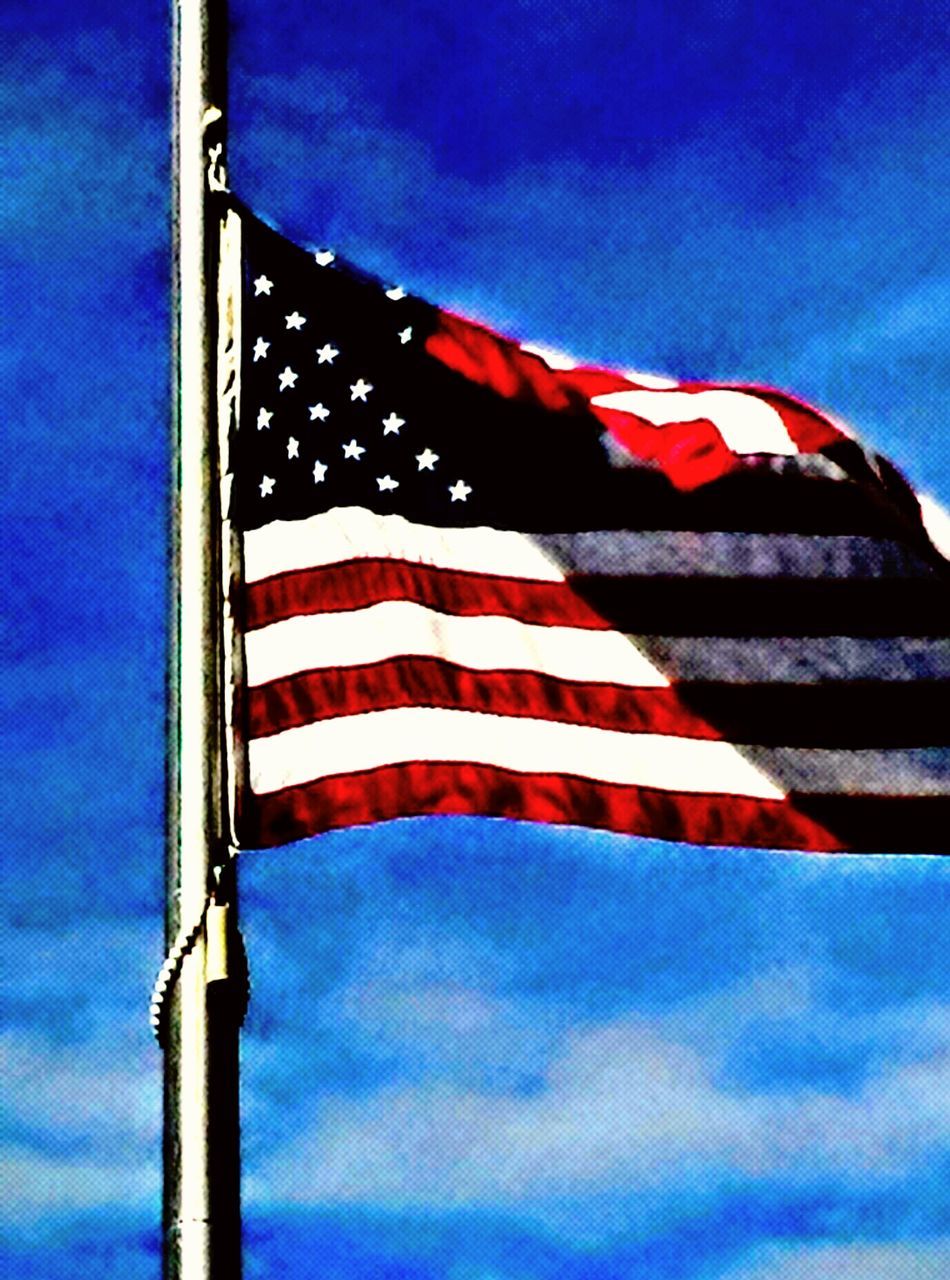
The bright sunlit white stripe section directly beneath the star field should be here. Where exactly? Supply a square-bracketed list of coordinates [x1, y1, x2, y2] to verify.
[245, 507, 563, 582]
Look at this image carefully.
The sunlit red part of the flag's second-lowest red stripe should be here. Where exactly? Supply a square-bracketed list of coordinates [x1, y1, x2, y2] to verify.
[247, 658, 722, 739]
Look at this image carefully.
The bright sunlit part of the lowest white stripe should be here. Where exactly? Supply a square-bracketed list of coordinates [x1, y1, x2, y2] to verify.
[248, 707, 782, 800]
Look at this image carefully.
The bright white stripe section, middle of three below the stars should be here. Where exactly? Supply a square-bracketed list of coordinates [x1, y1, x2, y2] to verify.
[245, 600, 670, 689]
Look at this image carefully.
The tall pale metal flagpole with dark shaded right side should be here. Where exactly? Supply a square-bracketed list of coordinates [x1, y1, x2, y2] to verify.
[163, 0, 241, 1280]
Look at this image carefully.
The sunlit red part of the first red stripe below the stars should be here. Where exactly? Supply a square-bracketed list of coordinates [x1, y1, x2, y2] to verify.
[238, 559, 611, 631]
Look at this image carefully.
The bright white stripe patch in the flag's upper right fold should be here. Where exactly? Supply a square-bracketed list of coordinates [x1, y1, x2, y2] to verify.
[590, 389, 798, 454]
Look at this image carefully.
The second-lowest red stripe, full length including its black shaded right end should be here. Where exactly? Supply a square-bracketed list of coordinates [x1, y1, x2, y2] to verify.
[247, 658, 950, 748]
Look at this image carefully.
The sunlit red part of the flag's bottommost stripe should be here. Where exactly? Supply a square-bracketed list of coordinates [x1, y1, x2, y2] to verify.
[242, 762, 844, 852]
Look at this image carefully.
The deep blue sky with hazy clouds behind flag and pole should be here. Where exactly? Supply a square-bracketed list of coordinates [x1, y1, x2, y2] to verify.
[0, 0, 950, 1280]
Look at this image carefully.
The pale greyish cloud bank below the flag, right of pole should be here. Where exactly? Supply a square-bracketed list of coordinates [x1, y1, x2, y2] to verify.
[248, 988, 950, 1239]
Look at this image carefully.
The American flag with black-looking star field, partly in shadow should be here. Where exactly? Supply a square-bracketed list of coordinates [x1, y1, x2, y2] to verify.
[225, 204, 950, 852]
